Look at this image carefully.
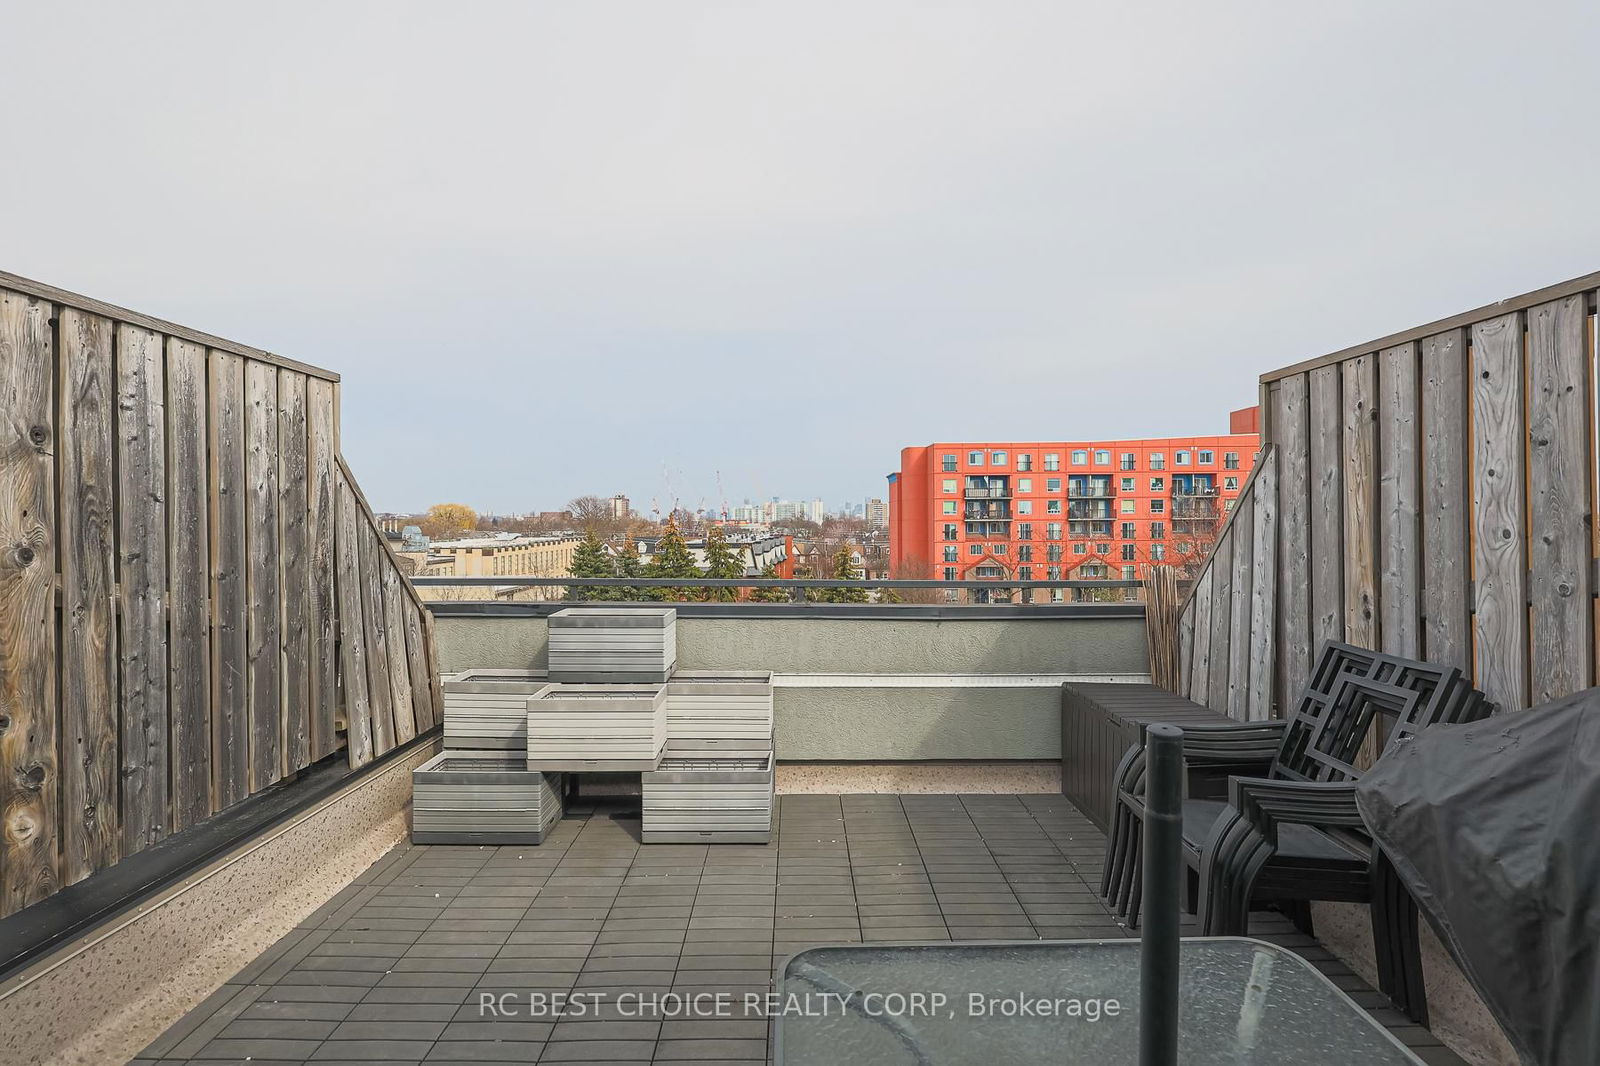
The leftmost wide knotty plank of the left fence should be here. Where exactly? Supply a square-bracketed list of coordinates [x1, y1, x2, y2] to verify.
[0, 290, 61, 914]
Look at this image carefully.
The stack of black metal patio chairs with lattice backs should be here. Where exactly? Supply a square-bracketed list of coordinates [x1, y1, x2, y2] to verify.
[1101, 642, 1493, 1015]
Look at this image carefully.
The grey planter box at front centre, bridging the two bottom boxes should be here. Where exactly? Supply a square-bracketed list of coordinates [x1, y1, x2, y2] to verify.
[526, 685, 667, 771]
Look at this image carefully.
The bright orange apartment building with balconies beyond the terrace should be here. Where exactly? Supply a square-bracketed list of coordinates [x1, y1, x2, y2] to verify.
[890, 408, 1259, 600]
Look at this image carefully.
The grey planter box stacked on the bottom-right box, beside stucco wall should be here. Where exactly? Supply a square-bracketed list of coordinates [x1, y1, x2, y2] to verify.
[667, 672, 773, 757]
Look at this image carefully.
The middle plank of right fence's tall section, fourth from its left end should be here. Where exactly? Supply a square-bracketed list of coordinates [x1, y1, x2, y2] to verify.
[1378, 344, 1422, 659]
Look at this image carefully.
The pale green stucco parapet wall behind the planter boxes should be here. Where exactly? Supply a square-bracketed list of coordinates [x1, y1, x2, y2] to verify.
[435, 608, 1149, 762]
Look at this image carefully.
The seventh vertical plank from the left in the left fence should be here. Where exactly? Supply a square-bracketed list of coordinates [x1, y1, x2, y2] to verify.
[278, 370, 310, 773]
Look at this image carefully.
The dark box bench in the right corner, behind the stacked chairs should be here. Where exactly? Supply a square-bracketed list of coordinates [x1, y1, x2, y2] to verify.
[1061, 682, 1234, 832]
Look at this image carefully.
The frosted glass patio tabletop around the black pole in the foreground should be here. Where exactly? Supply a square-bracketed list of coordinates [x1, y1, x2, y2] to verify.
[773, 936, 1421, 1066]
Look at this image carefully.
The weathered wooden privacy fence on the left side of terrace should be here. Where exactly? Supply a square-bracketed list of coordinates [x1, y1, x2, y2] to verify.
[0, 274, 437, 916]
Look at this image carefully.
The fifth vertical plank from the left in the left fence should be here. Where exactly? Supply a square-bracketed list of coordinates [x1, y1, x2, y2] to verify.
[206, 349, 250, 810]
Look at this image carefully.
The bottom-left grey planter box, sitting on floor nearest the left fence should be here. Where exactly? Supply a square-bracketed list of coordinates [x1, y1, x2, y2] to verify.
[411, 751, 562, 844]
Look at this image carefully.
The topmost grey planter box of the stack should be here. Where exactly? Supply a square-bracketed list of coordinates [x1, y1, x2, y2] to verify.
[549, 607, 678, 685]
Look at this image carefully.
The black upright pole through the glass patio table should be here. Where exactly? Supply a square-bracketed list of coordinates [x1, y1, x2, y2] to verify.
[1139, 725, 1184, 1066]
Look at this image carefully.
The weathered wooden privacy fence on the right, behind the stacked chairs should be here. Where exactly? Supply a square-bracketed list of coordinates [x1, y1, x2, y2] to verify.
[1181, 274, 1600, 714]
